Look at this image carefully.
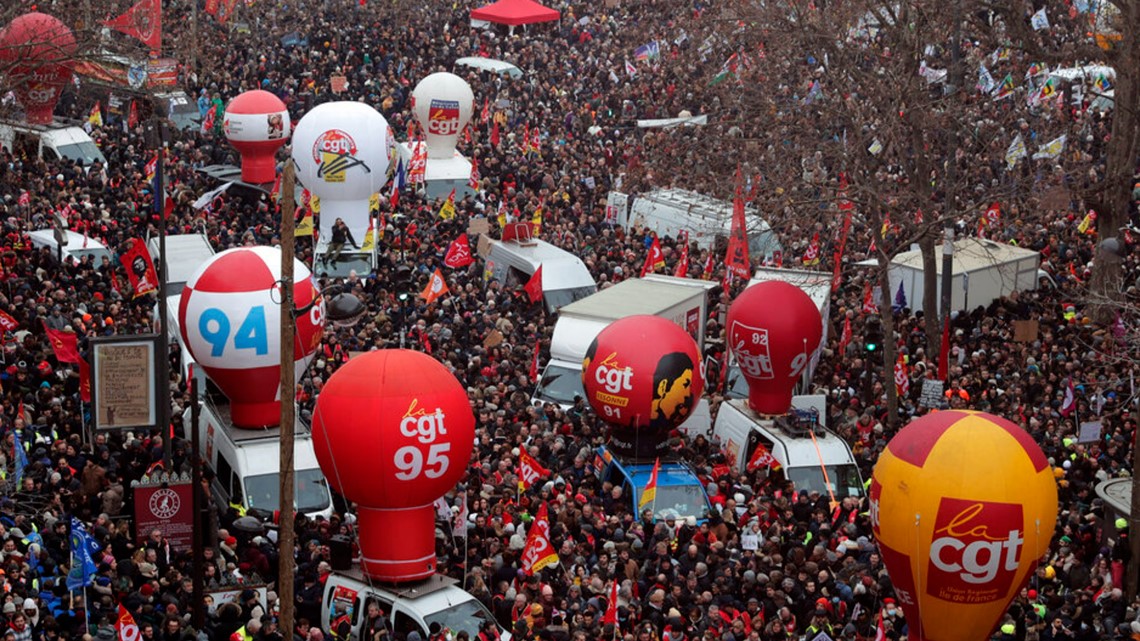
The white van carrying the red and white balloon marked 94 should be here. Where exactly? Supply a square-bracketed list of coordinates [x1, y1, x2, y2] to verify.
[189, 393, 333, 519]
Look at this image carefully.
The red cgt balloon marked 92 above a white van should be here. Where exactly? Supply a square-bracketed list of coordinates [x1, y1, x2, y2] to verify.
[728, 281, 823, 414]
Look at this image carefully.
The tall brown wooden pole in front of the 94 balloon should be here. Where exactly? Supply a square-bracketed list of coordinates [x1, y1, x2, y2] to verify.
[277, 160, 296, 638]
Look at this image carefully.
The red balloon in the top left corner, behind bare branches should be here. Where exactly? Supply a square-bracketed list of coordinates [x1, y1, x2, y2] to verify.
[0, 13, 75, 124]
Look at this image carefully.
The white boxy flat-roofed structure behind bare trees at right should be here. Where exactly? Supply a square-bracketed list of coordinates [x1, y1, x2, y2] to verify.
[857, 238, 1041, 309]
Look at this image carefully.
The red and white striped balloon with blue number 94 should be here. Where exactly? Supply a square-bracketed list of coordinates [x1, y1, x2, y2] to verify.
[178, 248, 325, 428]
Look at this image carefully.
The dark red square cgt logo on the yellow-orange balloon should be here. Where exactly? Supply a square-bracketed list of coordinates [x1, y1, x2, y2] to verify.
[927, 498, 1025, 603]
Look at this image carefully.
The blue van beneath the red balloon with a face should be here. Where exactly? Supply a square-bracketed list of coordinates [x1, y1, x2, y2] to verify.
[594, 445, 713, 524]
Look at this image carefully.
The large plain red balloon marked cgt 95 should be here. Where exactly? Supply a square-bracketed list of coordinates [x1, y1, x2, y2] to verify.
[312, 349, 475, 582]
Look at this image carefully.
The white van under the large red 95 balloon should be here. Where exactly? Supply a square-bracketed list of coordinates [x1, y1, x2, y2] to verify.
[320, 566, 511, 641]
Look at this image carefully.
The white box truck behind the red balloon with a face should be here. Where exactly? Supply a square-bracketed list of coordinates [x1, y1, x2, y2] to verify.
[531, 275, 718, 433]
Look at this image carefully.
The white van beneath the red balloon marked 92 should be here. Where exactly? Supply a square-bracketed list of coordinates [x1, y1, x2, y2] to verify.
[713, 395, 864, 501]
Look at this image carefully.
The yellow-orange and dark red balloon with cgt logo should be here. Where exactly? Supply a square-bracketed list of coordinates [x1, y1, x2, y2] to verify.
[871, 411, 1057, 641]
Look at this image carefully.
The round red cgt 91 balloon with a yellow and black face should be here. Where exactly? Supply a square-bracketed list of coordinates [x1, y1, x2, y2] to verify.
[581, 316, 705, 457]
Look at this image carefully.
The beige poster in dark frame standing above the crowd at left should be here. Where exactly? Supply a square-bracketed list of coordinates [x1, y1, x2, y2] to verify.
[91, 334, 159, 430]
